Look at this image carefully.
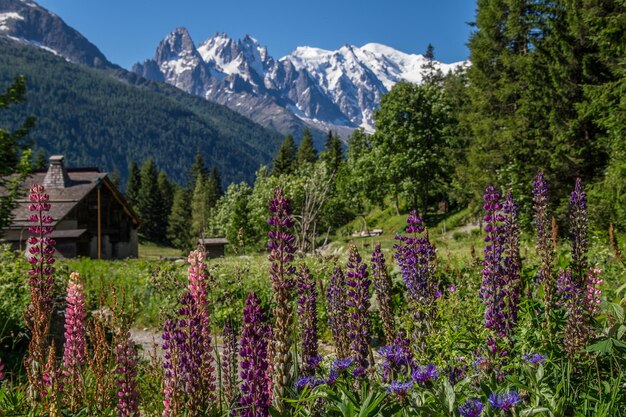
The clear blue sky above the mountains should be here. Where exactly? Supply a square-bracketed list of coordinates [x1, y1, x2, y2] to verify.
[35, 0, 475, 68]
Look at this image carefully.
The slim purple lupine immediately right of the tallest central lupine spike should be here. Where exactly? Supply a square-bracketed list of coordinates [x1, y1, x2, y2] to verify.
[297, 264, 319, 375]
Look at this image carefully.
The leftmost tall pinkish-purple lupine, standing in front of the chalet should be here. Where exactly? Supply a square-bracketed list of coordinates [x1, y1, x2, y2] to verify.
[24, 184, 55, 398]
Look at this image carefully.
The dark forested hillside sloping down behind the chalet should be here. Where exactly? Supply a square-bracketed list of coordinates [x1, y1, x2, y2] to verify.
[0, 39, 280, 183]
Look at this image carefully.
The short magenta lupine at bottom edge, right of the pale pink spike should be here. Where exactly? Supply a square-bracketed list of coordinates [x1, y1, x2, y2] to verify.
[114, 331, 139, 417]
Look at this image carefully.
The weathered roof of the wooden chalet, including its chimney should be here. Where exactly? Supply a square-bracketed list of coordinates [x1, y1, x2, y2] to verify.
[1, 156, 139, 231]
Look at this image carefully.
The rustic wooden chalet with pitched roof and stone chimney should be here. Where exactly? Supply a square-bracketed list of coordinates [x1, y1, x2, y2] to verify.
[2, 155, 139, 259]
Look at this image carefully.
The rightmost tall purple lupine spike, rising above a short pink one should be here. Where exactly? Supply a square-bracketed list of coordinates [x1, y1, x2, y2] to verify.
[570, 178, 589, 287]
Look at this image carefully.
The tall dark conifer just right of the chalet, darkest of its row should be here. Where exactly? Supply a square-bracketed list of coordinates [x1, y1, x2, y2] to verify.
[137, 158, 162, 242]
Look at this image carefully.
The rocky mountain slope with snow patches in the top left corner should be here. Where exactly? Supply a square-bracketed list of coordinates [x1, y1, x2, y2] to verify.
[0, 0, 113, 68]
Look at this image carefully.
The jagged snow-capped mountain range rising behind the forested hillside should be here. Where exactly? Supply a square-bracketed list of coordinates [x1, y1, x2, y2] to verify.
[133, 28, 463, 133]
